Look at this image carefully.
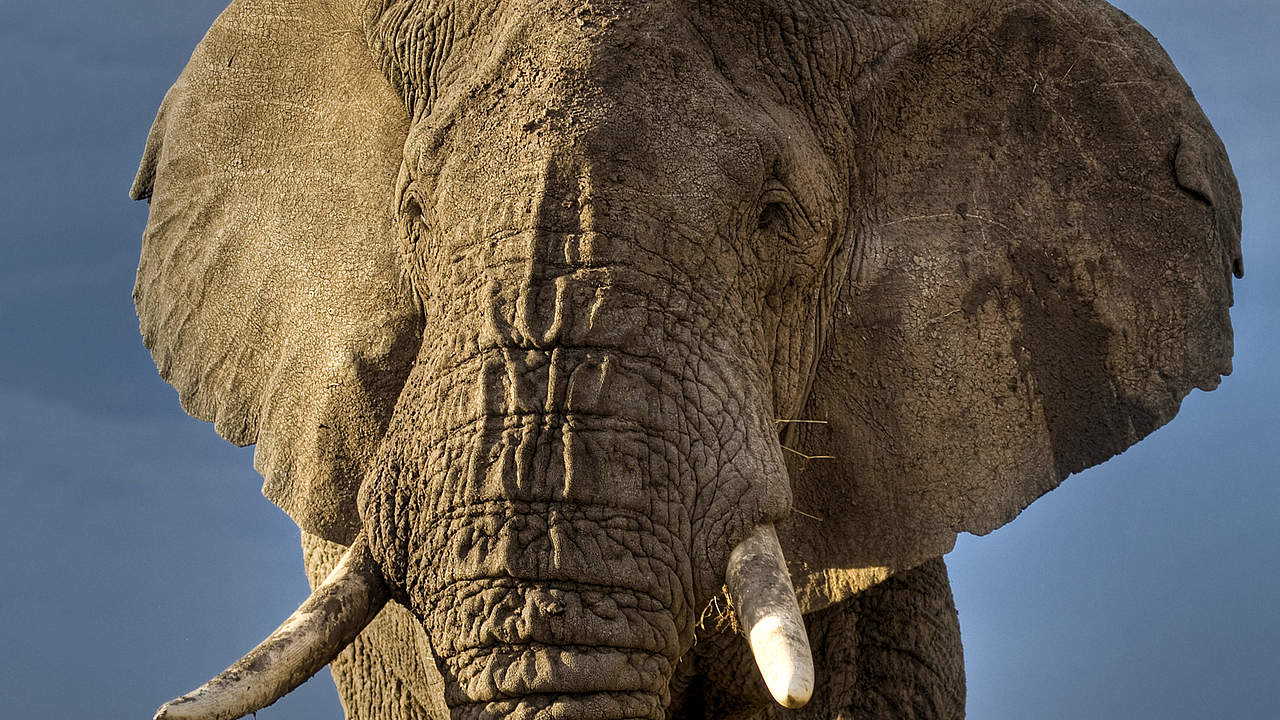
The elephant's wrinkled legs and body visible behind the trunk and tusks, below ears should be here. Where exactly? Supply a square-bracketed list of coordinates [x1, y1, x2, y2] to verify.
[302, 536, 965, 720]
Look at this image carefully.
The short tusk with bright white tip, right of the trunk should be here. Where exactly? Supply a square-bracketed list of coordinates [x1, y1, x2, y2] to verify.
[724, 525, 813, 707]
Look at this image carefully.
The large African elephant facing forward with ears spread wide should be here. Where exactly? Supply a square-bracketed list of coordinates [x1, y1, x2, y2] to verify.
[133, 0, 1242, 720]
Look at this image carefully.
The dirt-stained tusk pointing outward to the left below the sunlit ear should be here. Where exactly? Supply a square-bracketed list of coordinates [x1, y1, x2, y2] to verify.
[155, 534, 389, 720]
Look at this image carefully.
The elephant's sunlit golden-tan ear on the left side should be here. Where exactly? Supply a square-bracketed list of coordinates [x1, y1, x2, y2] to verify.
[132, 0, 421, 543]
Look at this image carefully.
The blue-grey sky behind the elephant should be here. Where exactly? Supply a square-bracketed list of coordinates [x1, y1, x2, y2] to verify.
[0, 0, 1280, 720]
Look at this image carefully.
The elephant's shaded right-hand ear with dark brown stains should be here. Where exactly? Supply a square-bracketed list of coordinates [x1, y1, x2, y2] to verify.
[780, 0, 1240, 610]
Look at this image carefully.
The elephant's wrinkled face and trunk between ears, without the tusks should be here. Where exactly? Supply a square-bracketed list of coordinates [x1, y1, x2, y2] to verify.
[361, 8, 850, 716]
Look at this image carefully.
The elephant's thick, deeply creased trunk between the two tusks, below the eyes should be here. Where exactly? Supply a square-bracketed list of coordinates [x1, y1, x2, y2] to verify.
[361, 283, 790, 720]
